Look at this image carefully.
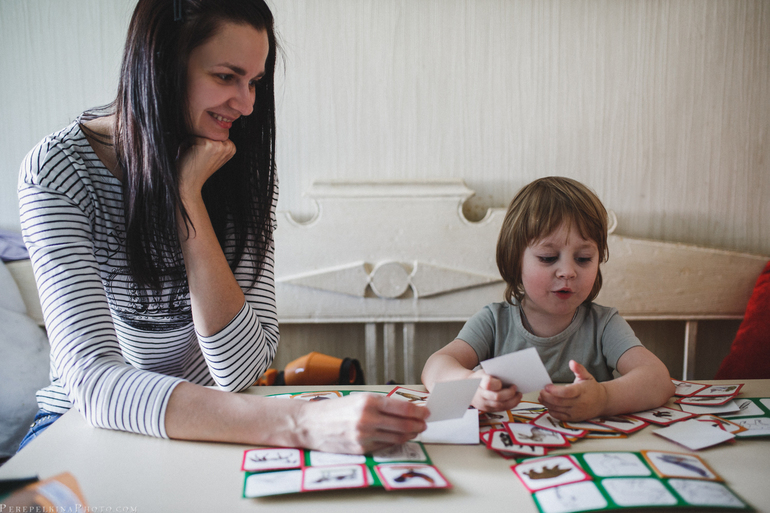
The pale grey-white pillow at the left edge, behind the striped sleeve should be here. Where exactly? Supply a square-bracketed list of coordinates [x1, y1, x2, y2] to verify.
[0, 261, 50, 461]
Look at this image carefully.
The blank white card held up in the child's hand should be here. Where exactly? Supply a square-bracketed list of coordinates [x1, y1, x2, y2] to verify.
[481, 347, 553, 394]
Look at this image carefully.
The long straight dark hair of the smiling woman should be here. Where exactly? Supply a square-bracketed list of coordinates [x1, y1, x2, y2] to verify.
[98, 0, 277, 289]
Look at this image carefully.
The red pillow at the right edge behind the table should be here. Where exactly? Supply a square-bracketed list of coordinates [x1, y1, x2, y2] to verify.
[714, 262, 770, 379]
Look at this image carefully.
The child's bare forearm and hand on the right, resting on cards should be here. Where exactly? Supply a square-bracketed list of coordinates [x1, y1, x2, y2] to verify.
[539, 346, 675, 422]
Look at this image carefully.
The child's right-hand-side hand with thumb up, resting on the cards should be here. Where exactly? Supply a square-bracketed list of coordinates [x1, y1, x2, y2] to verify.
[538, 360, 607, 422]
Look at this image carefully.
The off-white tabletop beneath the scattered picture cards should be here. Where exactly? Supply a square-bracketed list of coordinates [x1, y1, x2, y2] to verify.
[0, 380, 770, 513]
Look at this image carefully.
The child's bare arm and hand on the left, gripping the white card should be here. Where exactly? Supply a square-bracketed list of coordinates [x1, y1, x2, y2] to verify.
[422, 338, 521, 411]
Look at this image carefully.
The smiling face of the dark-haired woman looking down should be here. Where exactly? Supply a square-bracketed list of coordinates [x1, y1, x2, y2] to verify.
[187, 22, 270, 141]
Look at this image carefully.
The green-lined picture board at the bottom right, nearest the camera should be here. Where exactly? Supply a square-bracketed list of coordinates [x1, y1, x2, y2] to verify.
[511, 451, 751, 513]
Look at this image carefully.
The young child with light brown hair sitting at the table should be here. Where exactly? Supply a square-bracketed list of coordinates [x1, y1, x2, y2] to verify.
[422, 177, 674, 421]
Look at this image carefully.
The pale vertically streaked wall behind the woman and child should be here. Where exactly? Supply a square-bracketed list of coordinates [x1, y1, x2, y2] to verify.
[0, 0, 770, 376]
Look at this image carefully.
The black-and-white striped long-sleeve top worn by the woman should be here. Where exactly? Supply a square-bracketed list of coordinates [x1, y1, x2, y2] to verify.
[18, 122, 279, 437]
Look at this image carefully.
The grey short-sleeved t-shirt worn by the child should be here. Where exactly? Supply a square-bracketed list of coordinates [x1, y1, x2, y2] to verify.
[457, 302, 642, 383]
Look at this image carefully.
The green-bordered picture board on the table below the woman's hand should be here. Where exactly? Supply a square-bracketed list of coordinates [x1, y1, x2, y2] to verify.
[241, 442, 452, 498]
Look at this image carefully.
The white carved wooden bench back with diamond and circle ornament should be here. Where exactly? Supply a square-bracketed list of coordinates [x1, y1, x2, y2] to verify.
[275, 180, 769, 383]
